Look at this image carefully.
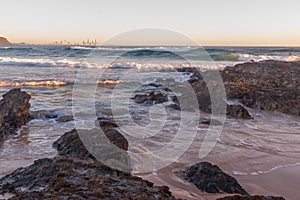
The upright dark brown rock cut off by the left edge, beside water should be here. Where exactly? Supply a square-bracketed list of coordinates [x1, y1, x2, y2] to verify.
[0, 89, 31, 141]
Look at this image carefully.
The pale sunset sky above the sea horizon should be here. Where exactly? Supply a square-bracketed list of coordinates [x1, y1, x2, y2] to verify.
[0, 0, 300, 46]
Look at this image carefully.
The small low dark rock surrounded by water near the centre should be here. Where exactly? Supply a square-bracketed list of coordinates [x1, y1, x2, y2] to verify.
[132, 91, 168, 104]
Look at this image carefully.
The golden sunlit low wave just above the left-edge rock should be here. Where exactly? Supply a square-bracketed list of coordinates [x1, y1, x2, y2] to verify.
[0, 80, 69, 87]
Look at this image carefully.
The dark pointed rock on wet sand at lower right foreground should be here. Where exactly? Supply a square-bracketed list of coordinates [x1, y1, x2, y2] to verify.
[183, 162, 247, 195]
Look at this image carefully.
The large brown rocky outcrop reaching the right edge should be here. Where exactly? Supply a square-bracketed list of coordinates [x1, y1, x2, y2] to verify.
[221, 60, 300, 116]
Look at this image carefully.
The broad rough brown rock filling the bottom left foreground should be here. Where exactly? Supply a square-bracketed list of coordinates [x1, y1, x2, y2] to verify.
[0, 157, 175, 200]
